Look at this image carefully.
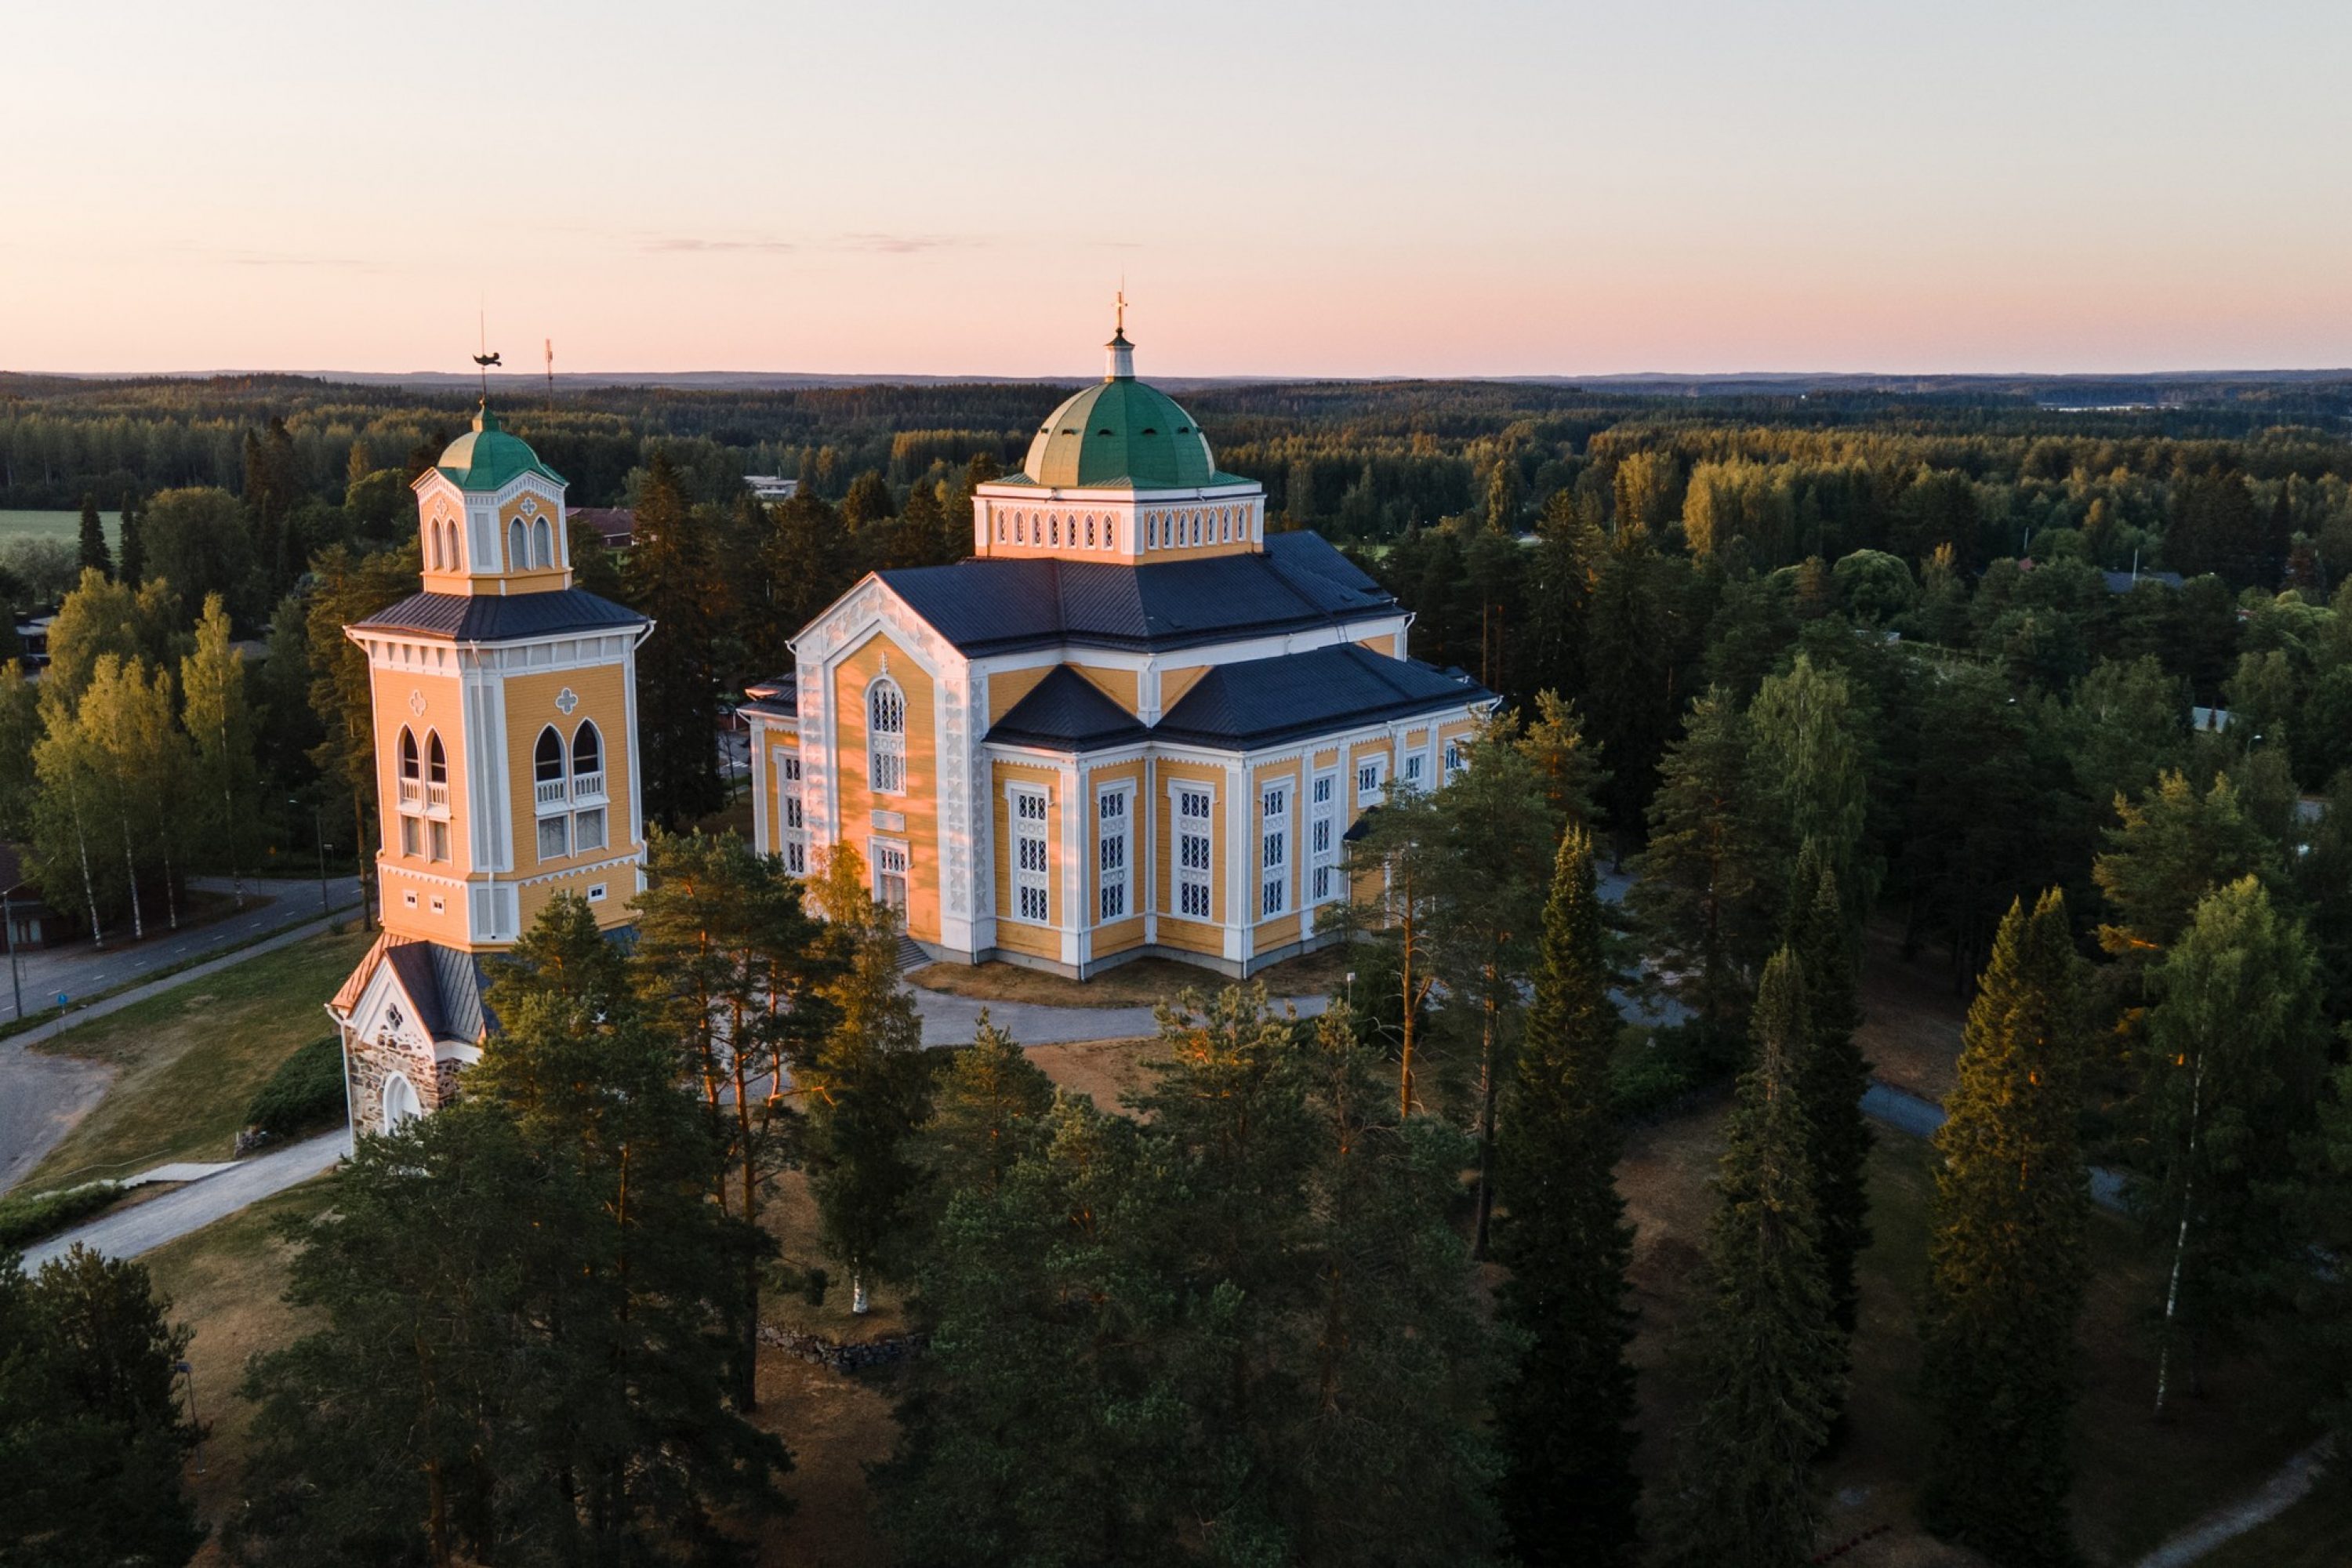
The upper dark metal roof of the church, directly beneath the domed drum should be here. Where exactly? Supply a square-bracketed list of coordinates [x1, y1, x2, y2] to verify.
[880, 534, 1397, 659]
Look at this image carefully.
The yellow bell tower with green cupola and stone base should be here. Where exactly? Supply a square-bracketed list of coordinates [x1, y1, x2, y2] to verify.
[329, 400, 654, 1131]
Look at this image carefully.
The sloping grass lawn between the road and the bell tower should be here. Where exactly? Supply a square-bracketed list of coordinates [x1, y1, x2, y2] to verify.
[21, 931, 369, 1192]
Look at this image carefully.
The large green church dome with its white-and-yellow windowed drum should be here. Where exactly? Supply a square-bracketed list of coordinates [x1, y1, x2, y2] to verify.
[971, 320, 1265, 564]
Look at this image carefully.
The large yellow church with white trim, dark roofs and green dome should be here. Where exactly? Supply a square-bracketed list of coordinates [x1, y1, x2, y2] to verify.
[743, 332, 1496, 978]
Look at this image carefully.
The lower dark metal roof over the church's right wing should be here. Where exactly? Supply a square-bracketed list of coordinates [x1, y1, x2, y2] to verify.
[1152, 642, 1494, 750]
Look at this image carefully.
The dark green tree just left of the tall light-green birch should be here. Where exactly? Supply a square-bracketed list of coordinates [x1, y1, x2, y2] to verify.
[1628, 687, 1771, 1036]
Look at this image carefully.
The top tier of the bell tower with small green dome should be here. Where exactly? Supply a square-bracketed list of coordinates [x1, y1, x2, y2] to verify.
[414, 400, 572, 595]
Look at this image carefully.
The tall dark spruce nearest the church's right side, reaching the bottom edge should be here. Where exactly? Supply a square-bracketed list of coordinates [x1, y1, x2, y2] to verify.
[1496, 827, 1639, 1568]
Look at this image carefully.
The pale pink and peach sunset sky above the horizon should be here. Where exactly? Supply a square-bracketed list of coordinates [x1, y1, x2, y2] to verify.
[0, 0, 2352, 376]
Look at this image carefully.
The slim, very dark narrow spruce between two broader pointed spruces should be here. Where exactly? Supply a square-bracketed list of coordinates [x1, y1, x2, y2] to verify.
[1788, 839, 1872, 1335]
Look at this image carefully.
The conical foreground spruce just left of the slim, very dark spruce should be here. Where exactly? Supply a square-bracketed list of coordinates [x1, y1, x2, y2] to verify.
[1668, 947, 1839, 1568]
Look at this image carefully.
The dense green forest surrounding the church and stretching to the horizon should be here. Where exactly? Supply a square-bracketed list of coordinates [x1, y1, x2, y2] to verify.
[0, 381, 2352, 1568]
